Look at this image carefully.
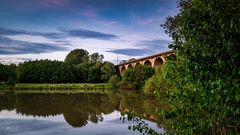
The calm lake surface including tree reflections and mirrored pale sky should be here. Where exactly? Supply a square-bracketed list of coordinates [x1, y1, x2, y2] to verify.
[0, 92, 163, 135]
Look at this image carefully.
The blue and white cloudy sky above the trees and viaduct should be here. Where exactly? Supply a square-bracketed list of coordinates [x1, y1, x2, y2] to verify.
[0, 0, 178, 64]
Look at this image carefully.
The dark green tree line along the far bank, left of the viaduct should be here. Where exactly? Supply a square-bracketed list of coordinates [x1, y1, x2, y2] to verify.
[0, 49, 116, 83]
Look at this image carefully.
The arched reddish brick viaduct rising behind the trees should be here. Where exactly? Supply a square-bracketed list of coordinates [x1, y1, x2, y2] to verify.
[115, 51, 174, 74]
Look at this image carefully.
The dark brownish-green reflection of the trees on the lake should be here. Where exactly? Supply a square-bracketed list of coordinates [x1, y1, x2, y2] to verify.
[0, 92, 161, 128]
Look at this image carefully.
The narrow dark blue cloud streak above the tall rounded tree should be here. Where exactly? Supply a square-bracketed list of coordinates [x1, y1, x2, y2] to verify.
[60, 29, 118, 40]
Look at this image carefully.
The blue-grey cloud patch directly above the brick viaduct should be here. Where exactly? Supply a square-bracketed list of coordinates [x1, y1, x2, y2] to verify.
[108, 39, 170, 56]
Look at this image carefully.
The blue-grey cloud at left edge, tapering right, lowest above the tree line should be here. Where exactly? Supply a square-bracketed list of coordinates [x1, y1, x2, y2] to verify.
[0, 36, 68, 55]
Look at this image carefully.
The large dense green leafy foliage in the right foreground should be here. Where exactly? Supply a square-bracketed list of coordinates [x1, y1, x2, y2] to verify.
[152, 0, 240, 134]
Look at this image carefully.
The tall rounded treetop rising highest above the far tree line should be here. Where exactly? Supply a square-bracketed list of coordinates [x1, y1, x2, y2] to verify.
[64, 49, 89, 64]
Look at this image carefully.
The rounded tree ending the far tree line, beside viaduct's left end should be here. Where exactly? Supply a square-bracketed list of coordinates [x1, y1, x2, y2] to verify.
[101, 62, 116, 82]
